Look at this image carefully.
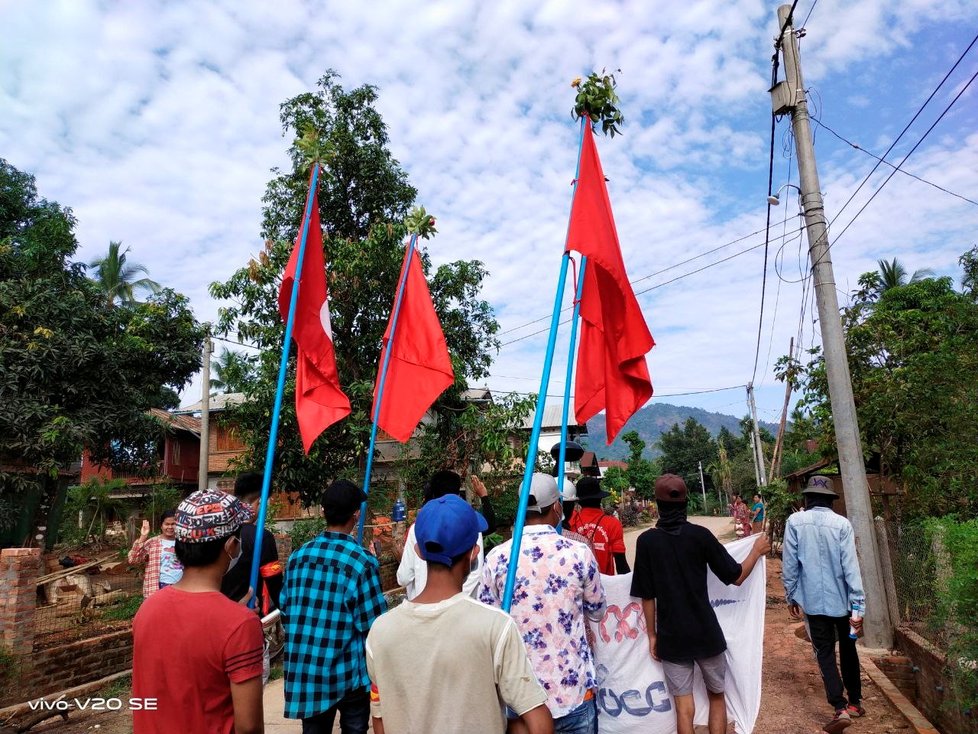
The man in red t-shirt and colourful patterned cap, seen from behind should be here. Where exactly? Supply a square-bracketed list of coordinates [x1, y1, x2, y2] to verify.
[132, 490, 264, 734]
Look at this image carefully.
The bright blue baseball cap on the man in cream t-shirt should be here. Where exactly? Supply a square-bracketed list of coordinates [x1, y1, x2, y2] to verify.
[414, 494, 489, 566]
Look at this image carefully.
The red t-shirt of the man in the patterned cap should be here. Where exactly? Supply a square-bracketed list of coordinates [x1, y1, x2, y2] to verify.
[132, 586, 264, 734]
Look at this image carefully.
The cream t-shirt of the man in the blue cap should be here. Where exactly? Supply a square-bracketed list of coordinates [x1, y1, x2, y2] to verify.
[366, 593, 547, 734]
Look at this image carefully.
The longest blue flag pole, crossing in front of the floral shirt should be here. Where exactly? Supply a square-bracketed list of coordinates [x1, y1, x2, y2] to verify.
[503, 117, 588, 613]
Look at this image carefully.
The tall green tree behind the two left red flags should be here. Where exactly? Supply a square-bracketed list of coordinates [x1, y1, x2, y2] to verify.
[210, 72, 508, 501]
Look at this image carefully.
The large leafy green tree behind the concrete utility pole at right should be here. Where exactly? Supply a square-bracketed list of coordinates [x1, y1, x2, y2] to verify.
[803, 264, 978, 517]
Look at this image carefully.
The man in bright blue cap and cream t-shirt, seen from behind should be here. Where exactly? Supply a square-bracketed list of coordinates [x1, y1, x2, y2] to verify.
[366, 495, 553, 734]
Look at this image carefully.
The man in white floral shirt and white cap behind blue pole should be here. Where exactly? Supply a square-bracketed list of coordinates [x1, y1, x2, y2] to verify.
[477, 474, 606, 734]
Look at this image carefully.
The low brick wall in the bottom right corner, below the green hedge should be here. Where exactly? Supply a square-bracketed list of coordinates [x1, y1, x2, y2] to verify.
[895, 627, 978, 734]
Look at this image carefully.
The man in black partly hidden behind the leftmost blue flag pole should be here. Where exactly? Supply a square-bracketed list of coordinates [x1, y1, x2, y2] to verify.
[221, 472, 283, 614]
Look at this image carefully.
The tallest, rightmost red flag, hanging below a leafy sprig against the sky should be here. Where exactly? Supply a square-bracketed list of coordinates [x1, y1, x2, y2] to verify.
[567, 122, 655, 444]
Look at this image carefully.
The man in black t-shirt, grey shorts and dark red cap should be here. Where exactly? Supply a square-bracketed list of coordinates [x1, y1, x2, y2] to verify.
[632, 474, 771, 734]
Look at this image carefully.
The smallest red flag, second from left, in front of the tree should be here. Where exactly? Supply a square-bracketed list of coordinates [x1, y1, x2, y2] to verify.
[374, 250, 455, 443]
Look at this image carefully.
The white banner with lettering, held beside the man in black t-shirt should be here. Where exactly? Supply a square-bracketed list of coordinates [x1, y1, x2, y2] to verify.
[591, 537, 767, 734]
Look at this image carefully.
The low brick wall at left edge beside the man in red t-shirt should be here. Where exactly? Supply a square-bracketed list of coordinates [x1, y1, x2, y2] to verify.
[0, 630, 132, 707]
